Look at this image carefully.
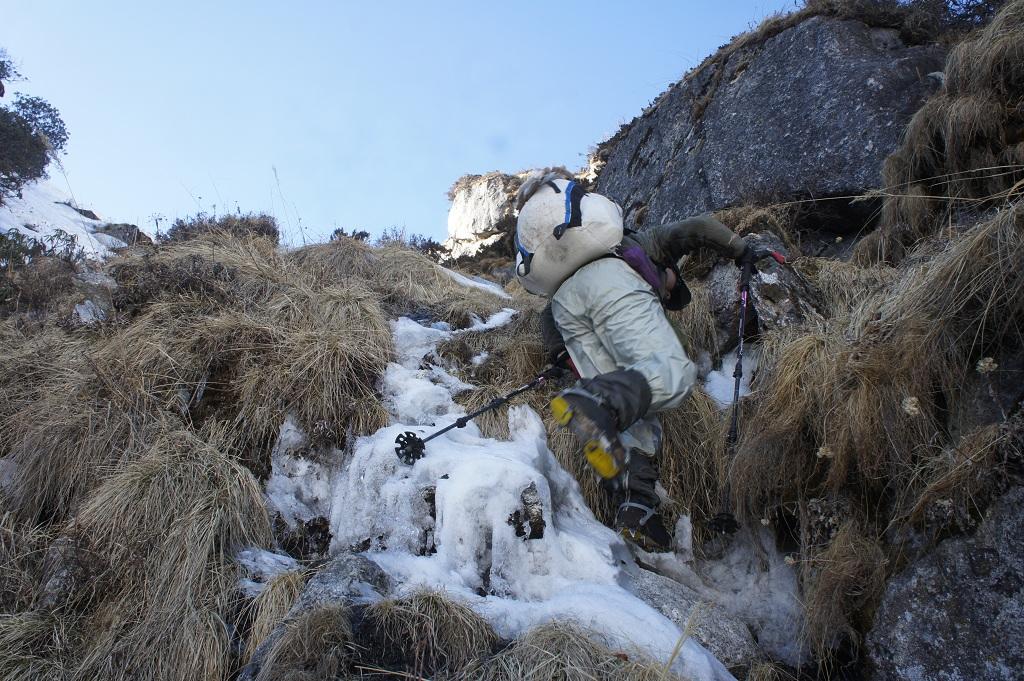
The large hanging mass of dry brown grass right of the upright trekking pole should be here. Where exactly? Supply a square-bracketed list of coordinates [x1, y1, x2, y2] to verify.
[734, 199, 1024, 501]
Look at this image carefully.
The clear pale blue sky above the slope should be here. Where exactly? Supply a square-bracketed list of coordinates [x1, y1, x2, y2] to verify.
[0, 0, 794, 244]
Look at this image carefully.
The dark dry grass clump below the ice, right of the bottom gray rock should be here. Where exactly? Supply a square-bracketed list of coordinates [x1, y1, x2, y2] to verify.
[365, 590, 498, 678]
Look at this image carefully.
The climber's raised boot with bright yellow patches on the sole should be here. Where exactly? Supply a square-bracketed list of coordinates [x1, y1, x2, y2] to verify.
[551, 389, 626, 480]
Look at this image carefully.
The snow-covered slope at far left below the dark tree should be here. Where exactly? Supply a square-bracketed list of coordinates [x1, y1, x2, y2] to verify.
[0, 179, 125, 257]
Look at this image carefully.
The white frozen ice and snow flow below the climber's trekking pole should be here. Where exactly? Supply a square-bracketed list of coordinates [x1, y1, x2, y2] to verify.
[331, 309, 732, 680]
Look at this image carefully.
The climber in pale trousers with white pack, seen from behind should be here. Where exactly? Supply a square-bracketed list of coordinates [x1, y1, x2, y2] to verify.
[515, 169, 754, 551]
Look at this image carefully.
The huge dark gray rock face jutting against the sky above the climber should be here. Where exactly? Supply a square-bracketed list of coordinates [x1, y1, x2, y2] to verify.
[597, 17, 944, 225]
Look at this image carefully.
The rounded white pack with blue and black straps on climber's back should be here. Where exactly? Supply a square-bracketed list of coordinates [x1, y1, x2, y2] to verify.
[515, 178, 623, 297]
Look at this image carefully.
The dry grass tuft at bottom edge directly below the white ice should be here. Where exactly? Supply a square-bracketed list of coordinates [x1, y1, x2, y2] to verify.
[468, 622, 678, 681]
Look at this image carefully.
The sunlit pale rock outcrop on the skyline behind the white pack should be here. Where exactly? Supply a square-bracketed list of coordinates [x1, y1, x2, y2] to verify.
[444, 172, 523, 258]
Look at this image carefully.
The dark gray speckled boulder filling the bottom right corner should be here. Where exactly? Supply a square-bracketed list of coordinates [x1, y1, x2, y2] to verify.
[867, 487, 1024, 681]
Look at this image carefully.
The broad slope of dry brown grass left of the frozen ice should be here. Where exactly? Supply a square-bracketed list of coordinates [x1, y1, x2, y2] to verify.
[0, 227, 528, 680]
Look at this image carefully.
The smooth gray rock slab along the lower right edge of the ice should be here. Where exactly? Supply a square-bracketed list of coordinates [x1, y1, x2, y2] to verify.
[626, 568, 764, 678]
